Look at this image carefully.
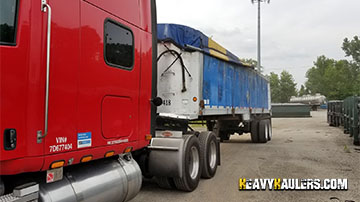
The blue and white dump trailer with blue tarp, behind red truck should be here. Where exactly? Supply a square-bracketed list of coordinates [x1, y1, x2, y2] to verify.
[157, 24, 272, 143]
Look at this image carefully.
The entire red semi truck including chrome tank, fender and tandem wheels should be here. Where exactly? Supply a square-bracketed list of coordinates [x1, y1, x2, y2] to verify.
[0, 0, 219, 202]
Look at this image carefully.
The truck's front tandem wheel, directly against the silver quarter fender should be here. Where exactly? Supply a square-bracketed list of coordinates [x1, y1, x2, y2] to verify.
[174, 135, 201, 192]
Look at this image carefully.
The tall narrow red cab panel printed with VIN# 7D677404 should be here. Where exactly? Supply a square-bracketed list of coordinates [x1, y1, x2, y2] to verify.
[44, 0, 80, 155]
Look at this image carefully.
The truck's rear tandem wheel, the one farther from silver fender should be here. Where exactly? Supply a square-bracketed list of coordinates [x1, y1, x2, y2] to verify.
[199, 132, 218, 179]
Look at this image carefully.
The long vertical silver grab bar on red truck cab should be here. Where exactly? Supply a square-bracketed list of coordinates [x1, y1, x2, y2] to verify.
[37, 0, 51, 143]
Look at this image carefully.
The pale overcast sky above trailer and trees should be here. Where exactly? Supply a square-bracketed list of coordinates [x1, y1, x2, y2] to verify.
[157, 0, 360, 87]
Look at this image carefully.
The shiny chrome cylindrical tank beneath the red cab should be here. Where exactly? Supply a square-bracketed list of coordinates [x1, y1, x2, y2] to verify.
[39, 155, 142, 202]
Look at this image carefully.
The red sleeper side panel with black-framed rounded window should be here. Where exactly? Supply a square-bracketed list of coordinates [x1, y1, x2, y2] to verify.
[78, 0, 140, 147]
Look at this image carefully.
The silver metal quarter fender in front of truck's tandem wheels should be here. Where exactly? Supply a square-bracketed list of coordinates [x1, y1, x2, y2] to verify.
[148, 138, 184, 178]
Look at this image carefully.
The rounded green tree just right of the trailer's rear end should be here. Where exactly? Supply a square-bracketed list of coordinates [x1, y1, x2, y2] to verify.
[279, 70, 297, 103]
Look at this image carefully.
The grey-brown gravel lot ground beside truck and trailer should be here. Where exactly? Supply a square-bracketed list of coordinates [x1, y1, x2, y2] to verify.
[132, 111, 360, 202]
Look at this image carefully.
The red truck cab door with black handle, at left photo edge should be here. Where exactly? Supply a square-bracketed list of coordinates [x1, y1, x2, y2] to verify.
[0, 0, 46, 175]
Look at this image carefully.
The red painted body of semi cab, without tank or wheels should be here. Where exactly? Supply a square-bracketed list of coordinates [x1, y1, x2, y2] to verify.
[0, 0, 153, 175]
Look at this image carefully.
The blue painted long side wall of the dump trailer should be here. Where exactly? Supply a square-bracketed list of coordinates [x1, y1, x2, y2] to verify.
[203, 54, 269, 109]
